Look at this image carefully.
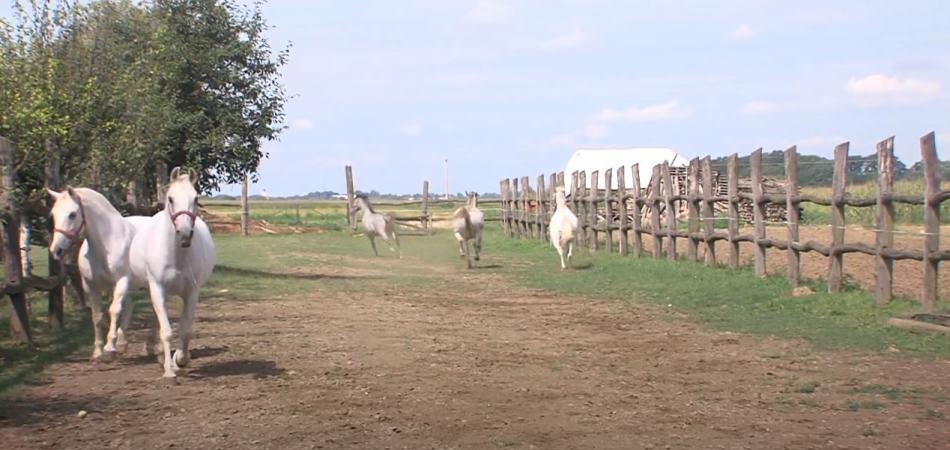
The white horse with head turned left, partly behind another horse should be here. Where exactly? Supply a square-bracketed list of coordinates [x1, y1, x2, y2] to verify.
[48, 188, 148, 361]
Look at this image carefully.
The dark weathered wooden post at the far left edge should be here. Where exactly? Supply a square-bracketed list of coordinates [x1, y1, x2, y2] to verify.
[0, 137, 33, 345]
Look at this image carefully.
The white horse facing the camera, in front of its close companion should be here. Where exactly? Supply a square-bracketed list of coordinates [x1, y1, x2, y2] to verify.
[129, 167, 215, 380]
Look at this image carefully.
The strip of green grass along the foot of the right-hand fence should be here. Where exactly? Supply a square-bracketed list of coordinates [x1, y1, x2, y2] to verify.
[485, 231, 950, 358]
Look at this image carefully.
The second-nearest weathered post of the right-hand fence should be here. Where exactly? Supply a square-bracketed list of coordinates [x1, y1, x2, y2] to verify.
[874, 136, 894, 305]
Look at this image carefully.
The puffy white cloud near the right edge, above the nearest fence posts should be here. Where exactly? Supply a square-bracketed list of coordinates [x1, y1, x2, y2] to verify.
[846, 74, 940, 106]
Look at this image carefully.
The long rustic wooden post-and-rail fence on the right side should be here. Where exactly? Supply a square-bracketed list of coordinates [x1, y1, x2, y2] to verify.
[500, 133, 950, 311]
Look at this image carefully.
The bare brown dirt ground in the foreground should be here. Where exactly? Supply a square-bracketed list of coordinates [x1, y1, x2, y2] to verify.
[0, 248, 950, 450]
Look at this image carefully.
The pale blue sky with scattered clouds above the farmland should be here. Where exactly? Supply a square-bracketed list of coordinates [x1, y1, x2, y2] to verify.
[7, 0, 950, 195]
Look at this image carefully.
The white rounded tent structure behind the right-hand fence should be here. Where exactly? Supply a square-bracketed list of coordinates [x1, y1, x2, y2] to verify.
[564, 147, 689, 192]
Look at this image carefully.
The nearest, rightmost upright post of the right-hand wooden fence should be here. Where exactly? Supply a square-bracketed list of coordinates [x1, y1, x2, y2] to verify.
[920, 132, 941, 312]
